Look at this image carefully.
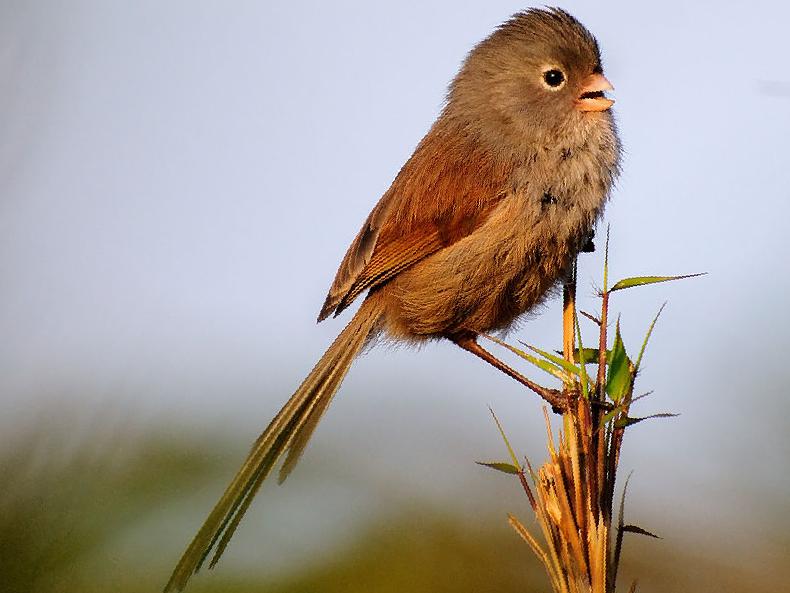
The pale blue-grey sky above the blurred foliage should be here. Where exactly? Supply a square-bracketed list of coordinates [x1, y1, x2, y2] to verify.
[0, 0, 790, 572]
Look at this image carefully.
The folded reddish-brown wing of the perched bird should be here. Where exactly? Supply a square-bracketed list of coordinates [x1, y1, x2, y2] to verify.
[318, 122, 513, 321]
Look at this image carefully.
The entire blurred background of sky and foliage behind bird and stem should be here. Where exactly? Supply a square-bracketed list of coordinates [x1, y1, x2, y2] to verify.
[0, 0, 790, 593]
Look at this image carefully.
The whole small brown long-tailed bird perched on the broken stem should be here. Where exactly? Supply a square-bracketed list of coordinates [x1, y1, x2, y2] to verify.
[165, 8, 620, 591]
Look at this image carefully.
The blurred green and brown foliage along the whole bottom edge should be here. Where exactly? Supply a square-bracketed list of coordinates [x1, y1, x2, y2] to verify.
[0, 416, 790, 593]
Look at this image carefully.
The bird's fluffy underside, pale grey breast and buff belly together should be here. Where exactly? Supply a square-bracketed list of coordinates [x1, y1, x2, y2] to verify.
[388, 119, 617, 338]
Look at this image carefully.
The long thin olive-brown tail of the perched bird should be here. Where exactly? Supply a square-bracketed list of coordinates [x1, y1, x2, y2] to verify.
[165, 295, 381, 592]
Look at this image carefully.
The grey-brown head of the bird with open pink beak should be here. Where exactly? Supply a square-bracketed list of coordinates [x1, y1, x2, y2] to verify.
[447, 8, 614, 146]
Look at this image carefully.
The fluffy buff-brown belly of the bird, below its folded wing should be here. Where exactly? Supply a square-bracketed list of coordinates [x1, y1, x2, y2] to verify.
[385, 197, 592, 340]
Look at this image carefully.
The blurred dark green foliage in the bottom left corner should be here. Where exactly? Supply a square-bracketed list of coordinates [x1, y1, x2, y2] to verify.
[0, 426, 220, 593]
